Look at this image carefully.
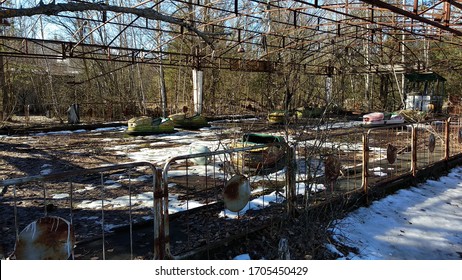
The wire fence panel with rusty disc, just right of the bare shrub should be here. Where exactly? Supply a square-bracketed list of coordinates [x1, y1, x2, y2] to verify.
[296, 130, 362, 206]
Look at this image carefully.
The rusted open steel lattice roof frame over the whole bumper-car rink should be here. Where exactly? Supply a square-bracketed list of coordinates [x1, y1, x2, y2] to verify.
[0, 0, 462, 74]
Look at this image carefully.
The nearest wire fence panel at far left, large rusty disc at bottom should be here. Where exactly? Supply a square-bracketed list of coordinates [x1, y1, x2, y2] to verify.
[0, 163, 158, 259]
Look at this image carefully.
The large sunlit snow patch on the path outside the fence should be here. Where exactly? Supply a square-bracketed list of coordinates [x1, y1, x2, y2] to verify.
[332, 167, 462, 260]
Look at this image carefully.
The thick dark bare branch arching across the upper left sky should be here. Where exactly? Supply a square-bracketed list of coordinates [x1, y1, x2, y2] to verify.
[0, 1, 223, 48]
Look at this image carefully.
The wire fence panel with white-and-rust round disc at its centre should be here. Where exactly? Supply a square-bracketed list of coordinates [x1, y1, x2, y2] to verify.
[163, 143, 287, 258]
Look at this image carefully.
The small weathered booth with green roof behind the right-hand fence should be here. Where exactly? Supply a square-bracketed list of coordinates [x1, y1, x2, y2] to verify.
[404, 72, 446, 113]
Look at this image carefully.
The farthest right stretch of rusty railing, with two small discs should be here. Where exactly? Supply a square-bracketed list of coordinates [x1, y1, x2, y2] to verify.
[362, 118, 462, 191]
